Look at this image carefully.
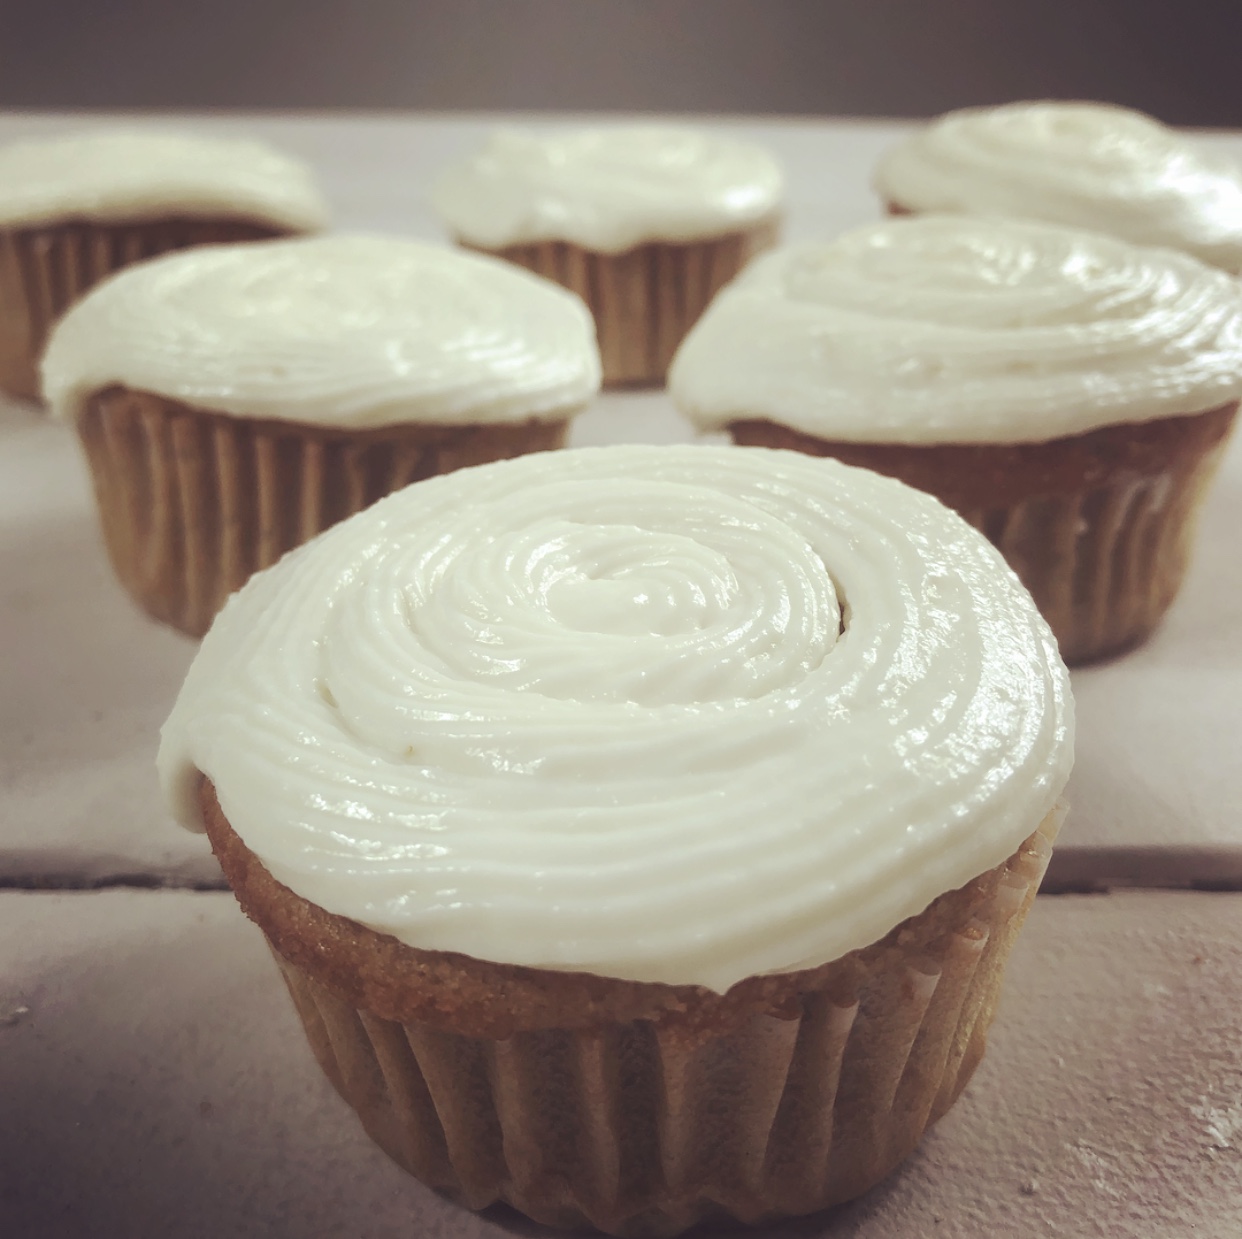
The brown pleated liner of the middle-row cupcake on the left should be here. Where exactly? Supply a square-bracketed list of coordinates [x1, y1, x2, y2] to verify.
[77, 387, 568, 637]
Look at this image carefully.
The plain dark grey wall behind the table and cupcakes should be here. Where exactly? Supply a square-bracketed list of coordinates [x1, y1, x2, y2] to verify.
[0, 0, 1242, 127]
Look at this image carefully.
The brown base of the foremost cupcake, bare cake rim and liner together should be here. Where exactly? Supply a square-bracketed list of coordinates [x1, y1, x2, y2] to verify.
[202, 783, 1063, 1235]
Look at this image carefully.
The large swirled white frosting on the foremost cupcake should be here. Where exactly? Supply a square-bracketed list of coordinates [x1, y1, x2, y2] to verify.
[159, 444, 1073, 991]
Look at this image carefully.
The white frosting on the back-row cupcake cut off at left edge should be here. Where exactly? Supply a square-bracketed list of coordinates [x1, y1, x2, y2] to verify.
[0, 129, 328, 232]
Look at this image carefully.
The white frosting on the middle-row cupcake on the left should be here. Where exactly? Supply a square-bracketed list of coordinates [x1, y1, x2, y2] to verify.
[42, 236, 600, 427]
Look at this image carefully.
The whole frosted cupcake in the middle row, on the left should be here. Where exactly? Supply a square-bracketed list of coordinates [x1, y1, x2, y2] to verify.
[43, 237, 600, 637]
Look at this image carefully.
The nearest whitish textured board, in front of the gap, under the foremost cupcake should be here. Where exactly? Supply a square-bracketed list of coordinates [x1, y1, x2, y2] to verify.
[0, 891, 1242, 1239]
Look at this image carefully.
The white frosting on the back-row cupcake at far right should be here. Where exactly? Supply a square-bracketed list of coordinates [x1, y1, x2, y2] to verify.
[876, 103, 1242, 272]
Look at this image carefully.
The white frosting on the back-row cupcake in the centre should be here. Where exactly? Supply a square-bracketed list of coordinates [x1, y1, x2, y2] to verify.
[432, 125, 784, 253]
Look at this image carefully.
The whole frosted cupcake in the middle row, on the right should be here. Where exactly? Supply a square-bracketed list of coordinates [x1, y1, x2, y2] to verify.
[669, 216, 1242, 664]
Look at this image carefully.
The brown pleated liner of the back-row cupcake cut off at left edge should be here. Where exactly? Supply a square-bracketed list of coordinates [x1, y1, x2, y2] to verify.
[0, 220, 288, 400]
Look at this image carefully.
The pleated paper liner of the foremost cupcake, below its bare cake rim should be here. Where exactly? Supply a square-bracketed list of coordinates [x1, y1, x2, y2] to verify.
[257, 806, 1063, 1235]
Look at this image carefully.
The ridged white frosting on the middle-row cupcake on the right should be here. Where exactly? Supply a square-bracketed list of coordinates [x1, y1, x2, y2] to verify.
[668, 216, 1242, 443]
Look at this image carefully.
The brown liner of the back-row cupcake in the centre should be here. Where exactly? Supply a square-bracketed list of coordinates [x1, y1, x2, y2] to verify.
[469, 221, 779, 386]
